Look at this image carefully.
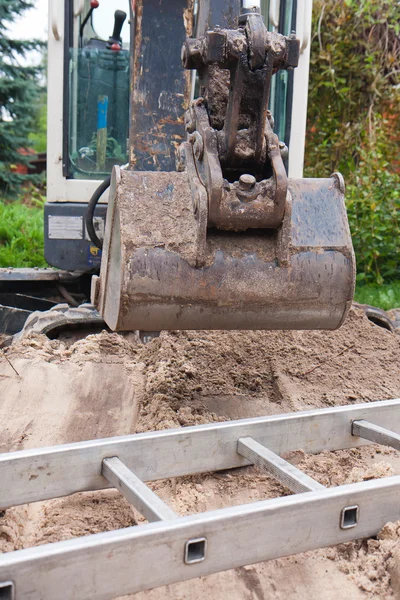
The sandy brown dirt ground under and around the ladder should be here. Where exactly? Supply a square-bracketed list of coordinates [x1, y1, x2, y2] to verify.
[0, 309, 400, 600]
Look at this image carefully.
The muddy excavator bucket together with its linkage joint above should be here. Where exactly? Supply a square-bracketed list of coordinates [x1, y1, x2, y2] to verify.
[92, 4, 355, 331]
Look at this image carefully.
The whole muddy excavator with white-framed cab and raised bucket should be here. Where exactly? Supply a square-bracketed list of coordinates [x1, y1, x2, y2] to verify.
[0, 0, 355, 338]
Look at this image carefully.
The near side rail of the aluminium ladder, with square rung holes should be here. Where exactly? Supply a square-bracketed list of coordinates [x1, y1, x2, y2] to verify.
[0, 476, 400, 600]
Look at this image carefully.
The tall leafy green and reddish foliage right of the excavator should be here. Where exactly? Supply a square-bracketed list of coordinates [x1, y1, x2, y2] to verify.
[305, 0, 400, 283]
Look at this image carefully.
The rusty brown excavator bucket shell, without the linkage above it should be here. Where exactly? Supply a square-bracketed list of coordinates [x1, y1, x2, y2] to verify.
[92, 167, 355, 331]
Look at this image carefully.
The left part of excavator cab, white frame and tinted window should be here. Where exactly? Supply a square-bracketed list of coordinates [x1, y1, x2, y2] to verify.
[44, 0, 134, 273]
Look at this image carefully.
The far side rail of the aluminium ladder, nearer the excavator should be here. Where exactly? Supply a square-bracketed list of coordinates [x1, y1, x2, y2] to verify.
[0, 399, 400, 510]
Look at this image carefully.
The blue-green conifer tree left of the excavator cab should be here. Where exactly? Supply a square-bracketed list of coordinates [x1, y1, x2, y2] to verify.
[0, 0, 42, 195]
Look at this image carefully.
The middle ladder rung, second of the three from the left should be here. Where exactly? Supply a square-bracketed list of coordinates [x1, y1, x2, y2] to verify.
[237, 437, 325, 493]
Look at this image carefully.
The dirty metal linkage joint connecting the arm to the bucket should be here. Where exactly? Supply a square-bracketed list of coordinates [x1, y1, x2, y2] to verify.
[183, 12, 295, 231]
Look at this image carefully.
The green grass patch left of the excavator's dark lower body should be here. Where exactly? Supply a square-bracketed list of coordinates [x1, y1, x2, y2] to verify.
[0, 201, 48, 267]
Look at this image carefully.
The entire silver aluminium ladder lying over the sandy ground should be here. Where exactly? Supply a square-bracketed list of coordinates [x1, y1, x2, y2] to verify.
[0, 399, 400, 600]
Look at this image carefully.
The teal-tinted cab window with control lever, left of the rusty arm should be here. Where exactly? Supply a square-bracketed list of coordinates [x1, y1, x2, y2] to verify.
[67, 2, 130, 179]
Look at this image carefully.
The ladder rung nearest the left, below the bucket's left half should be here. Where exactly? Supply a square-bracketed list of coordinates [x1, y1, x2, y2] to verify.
[102, 456, 178, 522]
